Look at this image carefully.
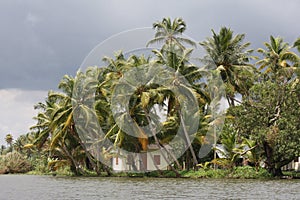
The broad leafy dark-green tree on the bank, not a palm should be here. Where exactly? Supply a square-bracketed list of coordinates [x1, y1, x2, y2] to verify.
[229, 79, 300, 175]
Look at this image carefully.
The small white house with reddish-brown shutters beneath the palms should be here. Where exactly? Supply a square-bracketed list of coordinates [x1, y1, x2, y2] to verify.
[112, 144, 170, 171]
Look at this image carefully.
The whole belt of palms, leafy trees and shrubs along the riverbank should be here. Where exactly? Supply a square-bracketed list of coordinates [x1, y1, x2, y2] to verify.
[0, 18, 300, 177]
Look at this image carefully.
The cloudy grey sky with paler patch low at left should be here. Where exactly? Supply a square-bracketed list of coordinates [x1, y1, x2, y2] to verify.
[0, 0, 300, 144]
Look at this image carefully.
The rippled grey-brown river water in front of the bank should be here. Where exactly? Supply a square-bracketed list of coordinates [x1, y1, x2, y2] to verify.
[0, 175, 300, 200]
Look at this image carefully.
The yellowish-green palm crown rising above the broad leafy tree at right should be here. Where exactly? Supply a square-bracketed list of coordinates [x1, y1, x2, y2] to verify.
[256, 36, 299, 81]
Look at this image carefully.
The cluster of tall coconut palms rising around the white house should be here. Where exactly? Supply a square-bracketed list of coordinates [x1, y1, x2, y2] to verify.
[14, 18, 300, 177]
